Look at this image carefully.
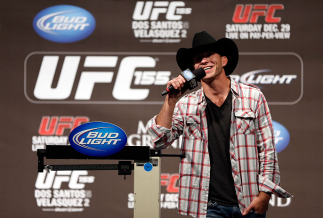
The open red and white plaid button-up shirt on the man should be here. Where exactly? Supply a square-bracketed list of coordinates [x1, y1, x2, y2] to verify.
[148, 79, 291, 218]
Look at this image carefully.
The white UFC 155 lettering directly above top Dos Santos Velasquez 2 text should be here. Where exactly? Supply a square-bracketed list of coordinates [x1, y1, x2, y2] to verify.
[132, 1, 192, 20]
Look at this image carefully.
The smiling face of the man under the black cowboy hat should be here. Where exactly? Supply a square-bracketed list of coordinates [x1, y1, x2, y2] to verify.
[193, 51, 228, 81]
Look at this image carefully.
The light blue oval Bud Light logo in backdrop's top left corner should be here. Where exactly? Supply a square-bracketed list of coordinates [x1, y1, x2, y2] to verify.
[33, 5, 95, 43]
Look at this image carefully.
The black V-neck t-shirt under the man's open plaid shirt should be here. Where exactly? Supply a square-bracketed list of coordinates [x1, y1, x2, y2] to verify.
[205, 91, 238, 206]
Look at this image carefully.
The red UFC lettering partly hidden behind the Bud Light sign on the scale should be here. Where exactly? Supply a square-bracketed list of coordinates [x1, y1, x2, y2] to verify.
[38, 116, 90, 136]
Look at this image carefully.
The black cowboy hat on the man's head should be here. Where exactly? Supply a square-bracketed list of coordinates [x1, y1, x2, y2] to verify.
[176, 31, 239, 76]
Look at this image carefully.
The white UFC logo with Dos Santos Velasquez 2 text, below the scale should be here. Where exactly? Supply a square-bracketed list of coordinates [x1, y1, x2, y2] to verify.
[34, 170, 95, 209]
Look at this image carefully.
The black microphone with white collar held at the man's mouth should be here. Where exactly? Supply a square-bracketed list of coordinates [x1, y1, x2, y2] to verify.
[162, 68, 206, 96]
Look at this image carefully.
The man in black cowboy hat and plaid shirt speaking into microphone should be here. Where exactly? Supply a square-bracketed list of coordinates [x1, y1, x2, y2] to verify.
[149, 31, 291, 217]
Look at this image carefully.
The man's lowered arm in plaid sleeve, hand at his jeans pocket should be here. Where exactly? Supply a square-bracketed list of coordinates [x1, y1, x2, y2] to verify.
[243, 92, 291, 215]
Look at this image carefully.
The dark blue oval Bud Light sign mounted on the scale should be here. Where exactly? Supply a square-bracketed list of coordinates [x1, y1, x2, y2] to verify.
[69, 122, 127, 157]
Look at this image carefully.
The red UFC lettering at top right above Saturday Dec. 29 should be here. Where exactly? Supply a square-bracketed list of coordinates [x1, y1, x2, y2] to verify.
[232, 4, 284, 23]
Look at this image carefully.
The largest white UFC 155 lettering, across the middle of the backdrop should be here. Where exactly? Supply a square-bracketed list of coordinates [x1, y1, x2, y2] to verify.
[33, 55, 171, 100]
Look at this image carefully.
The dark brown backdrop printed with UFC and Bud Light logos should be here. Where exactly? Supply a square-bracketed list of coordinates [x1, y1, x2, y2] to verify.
[0, 0, 323, 218]
